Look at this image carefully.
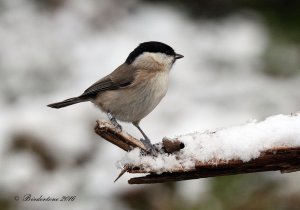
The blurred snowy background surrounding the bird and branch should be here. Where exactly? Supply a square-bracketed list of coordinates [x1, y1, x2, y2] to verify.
[0, 0, 300, 210]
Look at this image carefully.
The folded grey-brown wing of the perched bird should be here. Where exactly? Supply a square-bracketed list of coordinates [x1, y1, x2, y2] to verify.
[80, 63, 135, 97]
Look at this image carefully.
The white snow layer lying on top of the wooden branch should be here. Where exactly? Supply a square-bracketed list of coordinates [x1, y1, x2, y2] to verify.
[119, 113, 300, 173]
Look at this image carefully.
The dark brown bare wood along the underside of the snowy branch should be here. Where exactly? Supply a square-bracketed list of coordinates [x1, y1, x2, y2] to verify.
[128, 147, 300, 184]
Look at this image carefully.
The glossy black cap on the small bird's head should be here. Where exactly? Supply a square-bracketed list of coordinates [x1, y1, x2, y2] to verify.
[125, 41, 176, 64]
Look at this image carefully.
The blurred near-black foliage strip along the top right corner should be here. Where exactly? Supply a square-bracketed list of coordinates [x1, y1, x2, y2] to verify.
[145, 0, 300, 39]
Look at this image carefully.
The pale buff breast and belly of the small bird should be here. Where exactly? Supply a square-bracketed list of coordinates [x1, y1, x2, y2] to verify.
[93, 73, 169, 122]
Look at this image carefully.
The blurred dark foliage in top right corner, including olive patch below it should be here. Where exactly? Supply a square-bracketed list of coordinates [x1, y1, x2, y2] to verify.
[144, 0, 300, 77]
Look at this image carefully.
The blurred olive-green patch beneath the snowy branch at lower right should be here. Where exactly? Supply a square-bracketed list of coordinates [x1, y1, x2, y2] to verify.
[205, 172, 300, 210]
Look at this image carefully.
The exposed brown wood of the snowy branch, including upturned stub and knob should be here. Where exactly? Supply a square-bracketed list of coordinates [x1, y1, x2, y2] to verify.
[95, 121, 300, 184]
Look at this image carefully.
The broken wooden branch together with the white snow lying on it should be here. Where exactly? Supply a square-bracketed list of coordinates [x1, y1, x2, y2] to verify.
[95, 113, 300, 184]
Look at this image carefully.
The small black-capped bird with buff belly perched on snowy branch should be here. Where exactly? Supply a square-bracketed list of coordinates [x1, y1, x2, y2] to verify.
[47, 41, 183, 152]
